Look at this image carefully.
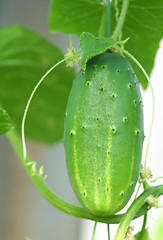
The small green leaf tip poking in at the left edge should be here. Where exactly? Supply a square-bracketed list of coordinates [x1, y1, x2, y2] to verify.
[0, 106, 15, 135]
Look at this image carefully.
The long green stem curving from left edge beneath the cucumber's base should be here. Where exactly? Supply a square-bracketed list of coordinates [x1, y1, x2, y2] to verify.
[6, 130, 158, 224]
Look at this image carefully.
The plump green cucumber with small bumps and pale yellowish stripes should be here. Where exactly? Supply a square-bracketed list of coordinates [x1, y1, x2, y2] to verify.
[64, 53, 144, 216]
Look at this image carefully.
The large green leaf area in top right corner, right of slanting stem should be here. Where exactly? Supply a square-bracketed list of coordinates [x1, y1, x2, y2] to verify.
[111, 0, 163, 88]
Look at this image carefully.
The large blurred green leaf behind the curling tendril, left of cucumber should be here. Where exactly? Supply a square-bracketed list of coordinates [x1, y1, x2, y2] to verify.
[0, 26, 75, 143]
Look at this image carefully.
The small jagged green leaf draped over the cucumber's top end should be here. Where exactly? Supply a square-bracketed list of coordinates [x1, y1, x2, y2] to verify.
[78, 32, 117, 70]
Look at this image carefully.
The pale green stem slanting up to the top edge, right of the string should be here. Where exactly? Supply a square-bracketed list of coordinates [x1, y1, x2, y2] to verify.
[111, 0, 129, 39]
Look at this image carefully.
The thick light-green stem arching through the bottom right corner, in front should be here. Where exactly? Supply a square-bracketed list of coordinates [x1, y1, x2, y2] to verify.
[114, 185, 163, 240]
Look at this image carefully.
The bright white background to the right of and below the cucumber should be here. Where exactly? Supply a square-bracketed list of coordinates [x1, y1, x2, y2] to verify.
[79, 40, 163, 240]
